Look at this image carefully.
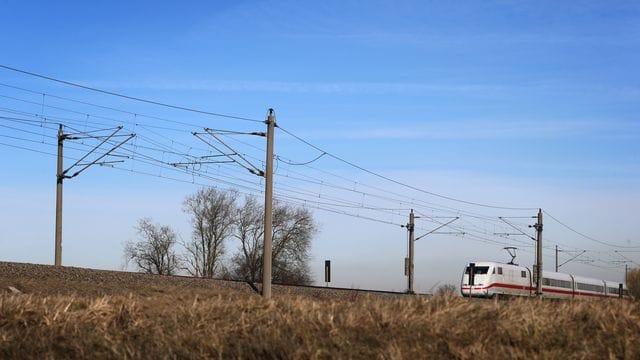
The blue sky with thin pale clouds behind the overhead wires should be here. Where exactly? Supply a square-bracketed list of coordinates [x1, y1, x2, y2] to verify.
[0, 0, 640, 291]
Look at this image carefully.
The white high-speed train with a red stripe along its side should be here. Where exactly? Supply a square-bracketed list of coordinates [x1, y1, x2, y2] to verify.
[460, 261, 629, 299]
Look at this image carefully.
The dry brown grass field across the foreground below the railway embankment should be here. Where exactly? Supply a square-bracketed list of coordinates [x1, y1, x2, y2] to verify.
[0, 293, 640, 359]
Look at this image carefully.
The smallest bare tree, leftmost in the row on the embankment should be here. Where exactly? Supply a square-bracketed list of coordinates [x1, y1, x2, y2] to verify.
[124, 218, 179, 275]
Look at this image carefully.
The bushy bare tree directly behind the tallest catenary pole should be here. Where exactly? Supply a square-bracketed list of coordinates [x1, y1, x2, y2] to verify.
[232, 197, 316, 284]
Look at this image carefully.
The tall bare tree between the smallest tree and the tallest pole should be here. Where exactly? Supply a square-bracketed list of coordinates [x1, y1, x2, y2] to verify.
[183, 188, 237, 278]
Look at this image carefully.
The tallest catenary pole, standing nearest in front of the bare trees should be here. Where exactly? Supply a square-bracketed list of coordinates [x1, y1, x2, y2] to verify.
[262, 109, 276, 299]
